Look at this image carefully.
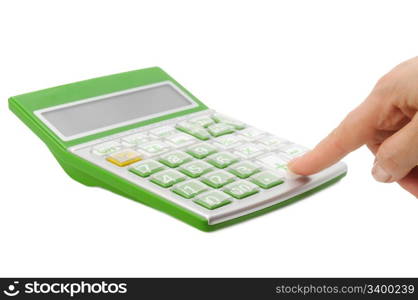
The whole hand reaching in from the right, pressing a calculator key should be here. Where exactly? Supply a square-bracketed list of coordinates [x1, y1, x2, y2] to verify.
[289, 57, 418, 197]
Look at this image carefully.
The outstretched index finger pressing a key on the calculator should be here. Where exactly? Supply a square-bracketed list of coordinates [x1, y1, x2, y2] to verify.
[288, 101, 375, 175]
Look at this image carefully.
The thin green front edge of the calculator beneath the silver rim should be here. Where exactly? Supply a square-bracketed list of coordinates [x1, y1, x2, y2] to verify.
[201, 172, 347, 232]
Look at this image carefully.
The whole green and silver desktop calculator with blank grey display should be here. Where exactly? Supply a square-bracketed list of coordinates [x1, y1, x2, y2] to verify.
[9, 67, 347, 231]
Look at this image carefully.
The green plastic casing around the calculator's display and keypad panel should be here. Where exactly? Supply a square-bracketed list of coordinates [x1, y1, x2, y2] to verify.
[9, 67, 345, 231]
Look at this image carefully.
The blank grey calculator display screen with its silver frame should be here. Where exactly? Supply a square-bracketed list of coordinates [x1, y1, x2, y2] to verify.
[40, 83, 196, 140]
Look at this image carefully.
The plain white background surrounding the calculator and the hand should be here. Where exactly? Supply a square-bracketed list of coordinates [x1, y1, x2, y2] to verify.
[0, 0, 418, 276]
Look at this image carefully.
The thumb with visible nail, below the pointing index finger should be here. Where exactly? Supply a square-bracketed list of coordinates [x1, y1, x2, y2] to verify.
[372, 114, 418, 182]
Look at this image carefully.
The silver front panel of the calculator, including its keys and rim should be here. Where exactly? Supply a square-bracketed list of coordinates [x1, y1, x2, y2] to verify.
[69, 110, 346, 225]
